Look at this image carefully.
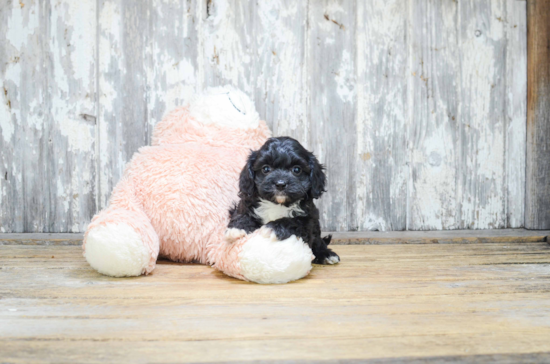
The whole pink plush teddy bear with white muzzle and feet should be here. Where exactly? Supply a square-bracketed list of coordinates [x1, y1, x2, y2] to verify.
[83, 87, 313, 283]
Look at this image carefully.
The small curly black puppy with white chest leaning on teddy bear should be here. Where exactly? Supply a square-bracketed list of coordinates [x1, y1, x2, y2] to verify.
[226, 137, 340, 264]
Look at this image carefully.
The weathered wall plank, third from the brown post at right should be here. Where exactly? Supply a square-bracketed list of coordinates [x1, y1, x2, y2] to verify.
[407, 0, 462, 230]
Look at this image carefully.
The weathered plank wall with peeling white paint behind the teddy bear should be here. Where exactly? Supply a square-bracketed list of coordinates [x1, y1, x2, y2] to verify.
[0, 0, 526, 232]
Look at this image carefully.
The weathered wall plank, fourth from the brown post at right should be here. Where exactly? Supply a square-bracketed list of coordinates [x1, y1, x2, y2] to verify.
[358, 1, 411, 231]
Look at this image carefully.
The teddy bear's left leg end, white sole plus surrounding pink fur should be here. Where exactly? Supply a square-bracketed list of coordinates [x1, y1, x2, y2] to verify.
[84, 208, 159, 277]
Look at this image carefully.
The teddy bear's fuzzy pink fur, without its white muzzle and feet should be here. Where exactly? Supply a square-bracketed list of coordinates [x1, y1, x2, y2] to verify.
[83, 108, 271, 279]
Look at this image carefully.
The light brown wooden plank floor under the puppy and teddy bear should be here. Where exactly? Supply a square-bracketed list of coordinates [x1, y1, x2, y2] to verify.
[0, 242, 550, 363]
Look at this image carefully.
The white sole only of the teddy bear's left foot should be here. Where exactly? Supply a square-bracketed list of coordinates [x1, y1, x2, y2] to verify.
[84, 224, 151, 277]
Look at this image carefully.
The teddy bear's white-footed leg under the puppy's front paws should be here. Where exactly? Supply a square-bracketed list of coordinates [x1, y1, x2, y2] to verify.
[214, 227, 315, 284]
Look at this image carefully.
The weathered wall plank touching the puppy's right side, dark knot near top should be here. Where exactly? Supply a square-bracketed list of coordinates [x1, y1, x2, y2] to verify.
[307, 0, 358, 231]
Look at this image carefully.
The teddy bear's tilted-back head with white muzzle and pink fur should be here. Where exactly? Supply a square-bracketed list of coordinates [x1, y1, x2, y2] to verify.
[152, 86, 271, 149]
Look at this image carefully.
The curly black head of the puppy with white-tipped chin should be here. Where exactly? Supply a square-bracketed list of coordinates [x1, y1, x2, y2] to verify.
[239, 137, 326, 206]
